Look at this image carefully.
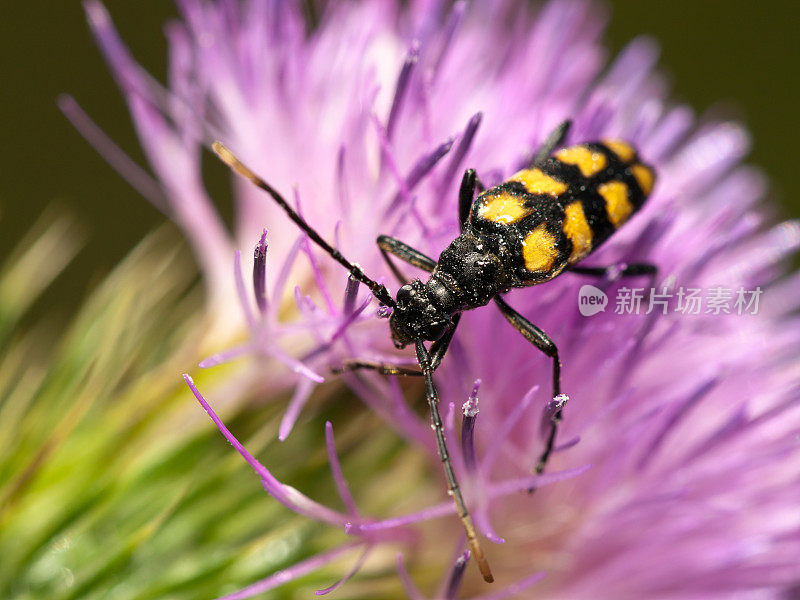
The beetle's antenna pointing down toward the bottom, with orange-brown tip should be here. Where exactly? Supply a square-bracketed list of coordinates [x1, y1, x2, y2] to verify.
[415, 338, 494, 583]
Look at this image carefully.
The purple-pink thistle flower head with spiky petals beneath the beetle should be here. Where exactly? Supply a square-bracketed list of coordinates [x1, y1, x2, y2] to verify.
[72, 0, 800, 598]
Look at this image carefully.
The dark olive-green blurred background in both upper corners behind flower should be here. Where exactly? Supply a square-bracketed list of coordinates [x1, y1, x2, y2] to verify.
[0, 0, 800, 317]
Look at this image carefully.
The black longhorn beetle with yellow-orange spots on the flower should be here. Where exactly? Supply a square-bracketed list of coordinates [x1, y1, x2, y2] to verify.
[213, 121, 656, 582]
